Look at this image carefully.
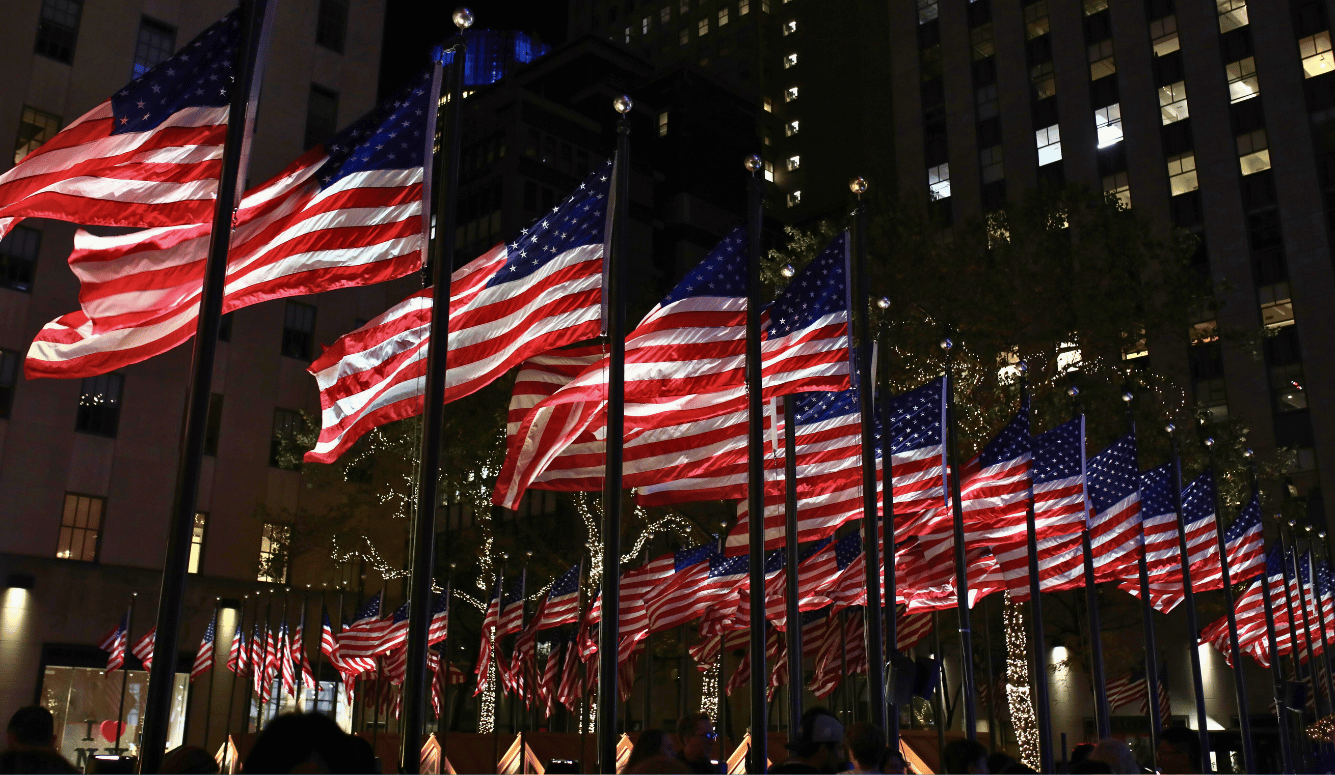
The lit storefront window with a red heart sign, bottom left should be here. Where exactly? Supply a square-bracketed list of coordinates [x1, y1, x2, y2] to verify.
[41, 664, 190, 771]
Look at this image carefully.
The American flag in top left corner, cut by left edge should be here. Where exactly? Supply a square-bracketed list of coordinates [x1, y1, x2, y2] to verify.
[0, 11, 242, 237]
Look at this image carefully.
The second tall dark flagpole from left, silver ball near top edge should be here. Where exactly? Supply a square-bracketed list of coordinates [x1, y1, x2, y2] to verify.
[400, 16, 473, 772]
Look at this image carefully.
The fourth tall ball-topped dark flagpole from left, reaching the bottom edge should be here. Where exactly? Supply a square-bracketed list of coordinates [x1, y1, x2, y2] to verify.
[746, 156, 769, 772]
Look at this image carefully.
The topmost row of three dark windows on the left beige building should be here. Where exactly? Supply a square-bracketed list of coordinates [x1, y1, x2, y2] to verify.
[33, 0, 347, 67]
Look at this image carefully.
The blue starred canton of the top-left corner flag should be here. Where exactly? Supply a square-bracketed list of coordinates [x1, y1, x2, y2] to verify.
[111, 9, 242, 135]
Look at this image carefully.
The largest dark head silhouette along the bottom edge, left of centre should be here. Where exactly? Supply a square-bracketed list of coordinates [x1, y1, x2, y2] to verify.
[244, 714, 363, 772]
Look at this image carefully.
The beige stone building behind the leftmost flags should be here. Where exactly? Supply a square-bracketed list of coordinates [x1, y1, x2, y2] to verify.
[0, 0, 389, 766]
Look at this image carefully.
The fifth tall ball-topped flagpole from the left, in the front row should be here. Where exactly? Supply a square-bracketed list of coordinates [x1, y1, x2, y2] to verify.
[848, 177, 889, 730]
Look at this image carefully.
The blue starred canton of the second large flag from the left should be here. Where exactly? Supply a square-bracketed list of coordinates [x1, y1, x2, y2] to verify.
[315, 72, 435, 188]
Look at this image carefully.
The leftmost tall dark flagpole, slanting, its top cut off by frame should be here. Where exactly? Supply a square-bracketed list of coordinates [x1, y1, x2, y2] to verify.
[139, 0, 276, 772]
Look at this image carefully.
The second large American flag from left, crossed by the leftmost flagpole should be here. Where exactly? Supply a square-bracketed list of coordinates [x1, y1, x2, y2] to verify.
[25, 68, 435, 377]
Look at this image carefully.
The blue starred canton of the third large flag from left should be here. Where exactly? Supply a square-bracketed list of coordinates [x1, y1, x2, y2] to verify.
[487, 161, 611, 288]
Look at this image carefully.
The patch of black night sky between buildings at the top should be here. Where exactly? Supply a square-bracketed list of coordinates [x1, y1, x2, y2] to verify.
[379, 0, 567, 96]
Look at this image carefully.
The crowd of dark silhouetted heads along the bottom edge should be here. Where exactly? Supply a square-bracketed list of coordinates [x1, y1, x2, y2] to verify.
[0, 706, 1202, 775]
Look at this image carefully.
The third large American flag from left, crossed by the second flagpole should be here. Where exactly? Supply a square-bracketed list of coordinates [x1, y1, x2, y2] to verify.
[306, 165, 610, 463]
